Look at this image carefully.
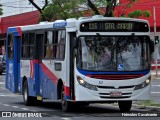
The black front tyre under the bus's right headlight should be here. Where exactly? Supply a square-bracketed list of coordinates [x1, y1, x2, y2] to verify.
[118, 101, 132, 112]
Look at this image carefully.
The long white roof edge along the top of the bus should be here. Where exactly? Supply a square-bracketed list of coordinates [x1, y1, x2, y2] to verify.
[8, 15, 149, 33]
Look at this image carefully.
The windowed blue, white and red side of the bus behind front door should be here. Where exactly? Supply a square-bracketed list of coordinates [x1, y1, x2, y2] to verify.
[6, 22, 70, 109]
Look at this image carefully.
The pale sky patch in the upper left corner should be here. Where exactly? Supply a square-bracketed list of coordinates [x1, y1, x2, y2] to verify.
[0, 0, 44, 17]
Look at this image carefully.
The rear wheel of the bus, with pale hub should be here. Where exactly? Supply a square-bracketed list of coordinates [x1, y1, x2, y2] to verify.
[23, 81, 35, 106]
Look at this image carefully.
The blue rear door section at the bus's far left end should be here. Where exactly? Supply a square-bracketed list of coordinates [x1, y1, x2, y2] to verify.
[6, 28, 22, 93]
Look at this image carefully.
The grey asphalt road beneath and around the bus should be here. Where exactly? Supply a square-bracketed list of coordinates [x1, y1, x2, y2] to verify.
[0, 75, 160, 120]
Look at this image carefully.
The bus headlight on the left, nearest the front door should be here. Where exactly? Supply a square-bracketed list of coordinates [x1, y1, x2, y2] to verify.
[77, 76, 98, 91]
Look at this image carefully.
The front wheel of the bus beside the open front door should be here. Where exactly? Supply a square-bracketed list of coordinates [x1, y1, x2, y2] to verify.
[61, 86, 71, 112]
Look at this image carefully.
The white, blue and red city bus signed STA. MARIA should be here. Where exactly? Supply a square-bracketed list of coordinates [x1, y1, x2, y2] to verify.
[6, 16, 154, 112]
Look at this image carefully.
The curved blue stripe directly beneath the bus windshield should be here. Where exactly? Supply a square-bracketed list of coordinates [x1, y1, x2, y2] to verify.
[77, 68, 150, 75]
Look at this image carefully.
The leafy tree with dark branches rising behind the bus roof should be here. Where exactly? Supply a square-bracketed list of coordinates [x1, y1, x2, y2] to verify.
[29, 0, 150, 21]
